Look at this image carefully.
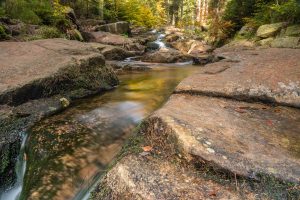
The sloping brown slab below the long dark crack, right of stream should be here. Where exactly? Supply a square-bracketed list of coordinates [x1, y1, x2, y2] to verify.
[143, 94, 300, 182]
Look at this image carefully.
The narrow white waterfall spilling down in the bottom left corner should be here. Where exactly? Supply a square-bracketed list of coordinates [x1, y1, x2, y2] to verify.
[0, 133, 27, 200]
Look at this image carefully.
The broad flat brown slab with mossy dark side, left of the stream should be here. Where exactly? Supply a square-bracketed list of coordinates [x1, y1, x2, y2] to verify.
[0, 39, 118, 104]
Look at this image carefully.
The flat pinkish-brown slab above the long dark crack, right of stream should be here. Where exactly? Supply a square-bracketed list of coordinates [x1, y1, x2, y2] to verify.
[176, 48, 300, 107]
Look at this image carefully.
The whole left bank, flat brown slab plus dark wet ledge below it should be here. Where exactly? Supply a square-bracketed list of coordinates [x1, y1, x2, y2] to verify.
[0, 39, 118, 190]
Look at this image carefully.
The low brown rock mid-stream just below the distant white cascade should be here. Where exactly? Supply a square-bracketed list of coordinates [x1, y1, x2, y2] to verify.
[141, 48, 192, 63]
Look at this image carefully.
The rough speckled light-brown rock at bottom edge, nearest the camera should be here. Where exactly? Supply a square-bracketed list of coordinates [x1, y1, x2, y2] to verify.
[91, 156, 251, 200]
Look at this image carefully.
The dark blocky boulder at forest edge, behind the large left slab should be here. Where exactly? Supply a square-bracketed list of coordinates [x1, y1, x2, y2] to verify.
[96, 21, 130, 34]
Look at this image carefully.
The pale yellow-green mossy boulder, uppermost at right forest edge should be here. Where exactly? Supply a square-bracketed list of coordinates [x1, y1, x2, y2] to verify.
[256, 22, 287, 38]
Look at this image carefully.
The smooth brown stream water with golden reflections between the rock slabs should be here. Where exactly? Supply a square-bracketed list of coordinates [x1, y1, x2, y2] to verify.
[17, 66, 197, 199]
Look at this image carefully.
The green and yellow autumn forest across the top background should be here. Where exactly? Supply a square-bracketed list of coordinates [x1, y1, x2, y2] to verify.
[0, 0, 300, 39]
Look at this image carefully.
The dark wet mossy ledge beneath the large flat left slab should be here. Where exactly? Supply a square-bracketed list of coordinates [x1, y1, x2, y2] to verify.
[0, 96, 69, 193]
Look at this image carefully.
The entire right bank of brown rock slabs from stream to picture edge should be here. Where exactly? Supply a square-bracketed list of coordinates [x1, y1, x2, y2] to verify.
[91, 47, 300, 199]
